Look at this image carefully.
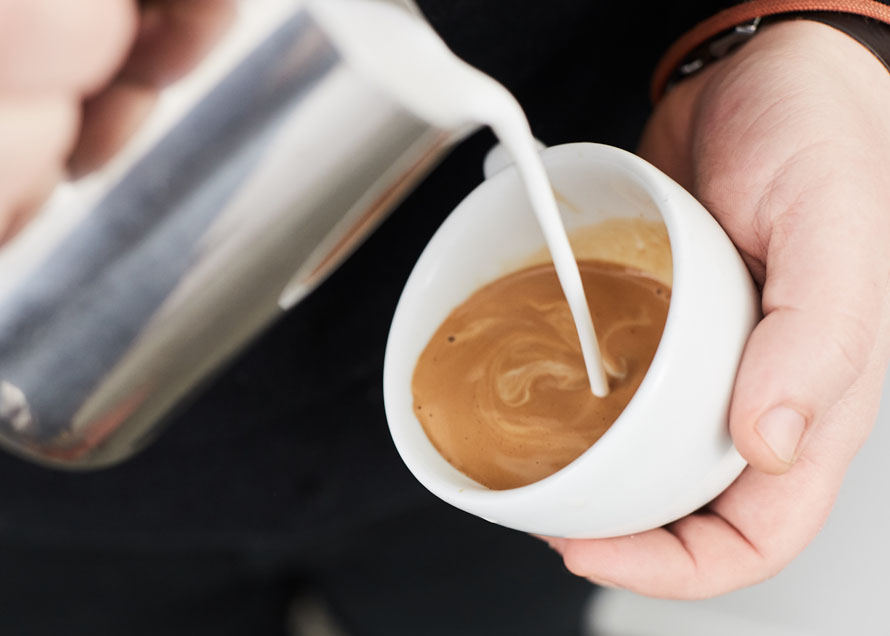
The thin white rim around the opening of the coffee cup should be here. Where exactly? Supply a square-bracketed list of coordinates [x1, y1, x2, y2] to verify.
[384, 142, 688, 506]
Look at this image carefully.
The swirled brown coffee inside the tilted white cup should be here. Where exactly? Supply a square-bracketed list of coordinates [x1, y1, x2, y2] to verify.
[412, 258, 670, 490]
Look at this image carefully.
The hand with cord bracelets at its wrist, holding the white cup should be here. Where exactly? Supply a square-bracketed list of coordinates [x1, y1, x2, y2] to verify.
[551, 21, 890, 598]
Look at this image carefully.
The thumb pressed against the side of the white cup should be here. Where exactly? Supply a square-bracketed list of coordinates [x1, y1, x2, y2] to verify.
[730, 202, 888, 474]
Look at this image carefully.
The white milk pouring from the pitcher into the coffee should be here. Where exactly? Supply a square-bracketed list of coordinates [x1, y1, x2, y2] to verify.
[308, 0, 609, 397]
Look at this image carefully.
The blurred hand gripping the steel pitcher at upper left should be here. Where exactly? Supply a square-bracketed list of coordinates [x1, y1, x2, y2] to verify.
[0, 0, 234, 244]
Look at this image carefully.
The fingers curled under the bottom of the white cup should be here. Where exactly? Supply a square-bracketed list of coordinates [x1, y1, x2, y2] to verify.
[547, 428, 845, 599]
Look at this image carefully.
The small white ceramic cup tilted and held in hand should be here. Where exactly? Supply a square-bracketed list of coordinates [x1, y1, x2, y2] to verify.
[383, 143, 759, 538]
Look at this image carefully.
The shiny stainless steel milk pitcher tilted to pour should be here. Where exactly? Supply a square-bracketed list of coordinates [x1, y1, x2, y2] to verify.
[0, 2, 457, 468]
